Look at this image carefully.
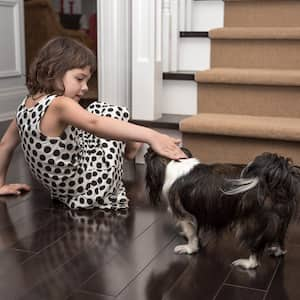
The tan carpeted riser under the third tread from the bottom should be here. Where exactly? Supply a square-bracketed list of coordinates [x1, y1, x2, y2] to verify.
[211, 39, 300, 69]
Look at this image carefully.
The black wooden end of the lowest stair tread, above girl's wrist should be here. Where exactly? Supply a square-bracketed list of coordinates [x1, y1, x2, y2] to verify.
[130, 114, 190, 130]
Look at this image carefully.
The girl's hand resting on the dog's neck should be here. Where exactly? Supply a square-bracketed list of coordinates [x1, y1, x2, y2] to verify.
[150, 132, 187, 160]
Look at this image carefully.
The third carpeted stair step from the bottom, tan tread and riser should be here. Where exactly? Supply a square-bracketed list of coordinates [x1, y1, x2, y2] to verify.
[209, 27, 300, 69]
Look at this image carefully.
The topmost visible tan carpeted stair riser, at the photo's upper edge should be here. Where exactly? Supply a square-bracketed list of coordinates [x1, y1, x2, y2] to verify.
[224, 0, 300, 27]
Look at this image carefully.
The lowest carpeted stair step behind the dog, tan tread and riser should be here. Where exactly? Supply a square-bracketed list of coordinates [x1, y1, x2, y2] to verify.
[180, 113, 300, 164]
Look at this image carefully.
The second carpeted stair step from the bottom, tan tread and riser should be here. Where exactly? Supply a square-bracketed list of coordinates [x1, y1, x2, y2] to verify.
[195, 68, 300, 118]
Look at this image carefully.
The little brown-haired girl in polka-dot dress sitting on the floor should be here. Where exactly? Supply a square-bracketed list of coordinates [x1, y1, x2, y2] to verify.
[0, 37, 185, 209]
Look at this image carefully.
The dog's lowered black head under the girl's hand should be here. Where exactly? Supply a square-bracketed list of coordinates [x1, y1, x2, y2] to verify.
[144, 148, 192, 204]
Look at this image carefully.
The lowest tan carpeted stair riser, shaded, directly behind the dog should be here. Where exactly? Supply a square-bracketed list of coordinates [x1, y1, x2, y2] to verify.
[182, 132, 300, 165]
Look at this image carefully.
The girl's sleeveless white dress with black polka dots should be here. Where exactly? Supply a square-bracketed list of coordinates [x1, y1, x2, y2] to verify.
[16, 95, 129, 209]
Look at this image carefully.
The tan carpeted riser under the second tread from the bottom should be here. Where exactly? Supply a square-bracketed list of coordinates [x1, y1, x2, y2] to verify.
[198, 83, 300, 118]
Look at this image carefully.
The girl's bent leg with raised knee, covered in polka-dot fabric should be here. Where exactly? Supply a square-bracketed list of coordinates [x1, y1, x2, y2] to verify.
[70, 102, 129, 209]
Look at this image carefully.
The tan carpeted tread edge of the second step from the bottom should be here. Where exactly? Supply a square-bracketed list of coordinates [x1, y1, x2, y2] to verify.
[195, 68, 300, 86]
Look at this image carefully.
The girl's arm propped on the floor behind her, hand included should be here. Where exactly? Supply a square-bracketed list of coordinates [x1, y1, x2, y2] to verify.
[0, 120, 30, 195]
